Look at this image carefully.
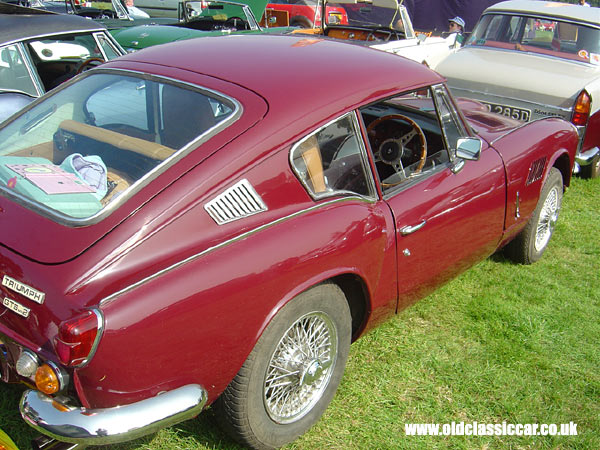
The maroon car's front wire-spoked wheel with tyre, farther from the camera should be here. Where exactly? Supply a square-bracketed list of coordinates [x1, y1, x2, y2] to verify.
[506, 167, 563, 264]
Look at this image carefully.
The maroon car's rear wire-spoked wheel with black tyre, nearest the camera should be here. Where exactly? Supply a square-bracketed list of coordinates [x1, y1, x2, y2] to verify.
[215, 284, 351, 449]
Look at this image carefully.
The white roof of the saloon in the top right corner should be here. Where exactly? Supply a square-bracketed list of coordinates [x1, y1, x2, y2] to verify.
[484, 0, 600, 27]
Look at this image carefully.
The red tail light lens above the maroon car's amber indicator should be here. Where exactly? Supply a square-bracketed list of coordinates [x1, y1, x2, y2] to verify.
[54, 310, 102, 367]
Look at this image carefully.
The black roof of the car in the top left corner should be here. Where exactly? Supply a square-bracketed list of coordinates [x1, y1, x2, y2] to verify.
[0, 6, 106, 45]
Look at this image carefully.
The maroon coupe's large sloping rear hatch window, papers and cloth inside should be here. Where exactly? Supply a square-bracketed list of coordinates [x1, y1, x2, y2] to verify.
[0, 69, 240, 225]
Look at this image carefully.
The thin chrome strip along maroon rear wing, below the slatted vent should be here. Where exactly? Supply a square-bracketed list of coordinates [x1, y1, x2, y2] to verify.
[98, 195, 374, 308]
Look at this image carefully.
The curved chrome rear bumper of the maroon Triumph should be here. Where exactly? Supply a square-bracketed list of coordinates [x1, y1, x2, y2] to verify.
[20, 384, 207, 445]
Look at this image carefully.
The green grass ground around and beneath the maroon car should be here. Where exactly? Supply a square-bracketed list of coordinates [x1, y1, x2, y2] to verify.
[0, 178, 600, 450]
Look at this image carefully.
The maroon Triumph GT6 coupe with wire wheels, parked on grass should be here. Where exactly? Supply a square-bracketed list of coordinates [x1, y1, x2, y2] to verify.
[0, 35, 577, 448]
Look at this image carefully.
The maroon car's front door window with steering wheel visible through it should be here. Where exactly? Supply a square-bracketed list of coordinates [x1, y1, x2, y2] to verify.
[360, 89, 449, 192]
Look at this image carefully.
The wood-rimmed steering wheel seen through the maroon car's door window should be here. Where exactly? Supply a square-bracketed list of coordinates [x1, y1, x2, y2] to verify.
[367, 114, 427, 178]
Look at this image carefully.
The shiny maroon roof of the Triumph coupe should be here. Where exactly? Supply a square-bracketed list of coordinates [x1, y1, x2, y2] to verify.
[106, 34, 445, 110]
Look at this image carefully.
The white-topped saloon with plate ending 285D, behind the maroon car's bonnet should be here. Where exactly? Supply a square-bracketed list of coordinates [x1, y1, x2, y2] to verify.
[436, 0, 600, 178]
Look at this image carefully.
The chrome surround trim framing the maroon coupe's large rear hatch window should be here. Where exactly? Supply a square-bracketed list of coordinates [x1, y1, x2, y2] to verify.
[0, 67, 243, 227]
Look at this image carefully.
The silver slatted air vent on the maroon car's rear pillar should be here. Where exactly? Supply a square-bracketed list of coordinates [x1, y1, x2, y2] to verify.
[204, 179, 267, 225]
